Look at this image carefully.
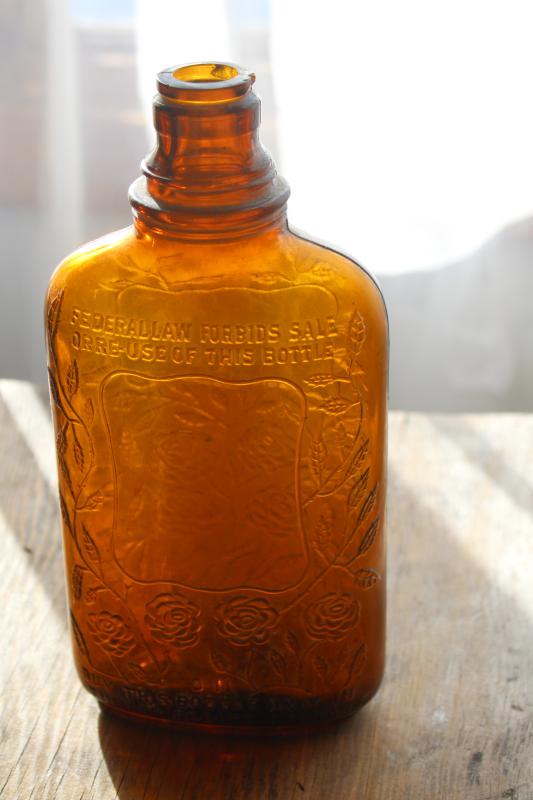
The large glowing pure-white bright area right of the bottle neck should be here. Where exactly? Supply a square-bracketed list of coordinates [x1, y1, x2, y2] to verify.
[271, 0, 533, 274]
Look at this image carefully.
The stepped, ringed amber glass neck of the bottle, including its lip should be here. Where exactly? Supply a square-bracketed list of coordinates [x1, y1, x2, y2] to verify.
[130, 64, 289, 240]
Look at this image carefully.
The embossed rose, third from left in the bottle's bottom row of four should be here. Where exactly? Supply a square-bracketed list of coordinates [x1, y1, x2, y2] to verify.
[215, 595, 278, 646]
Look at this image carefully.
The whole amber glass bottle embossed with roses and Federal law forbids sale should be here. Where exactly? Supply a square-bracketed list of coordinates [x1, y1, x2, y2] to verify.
[46, 64, 388, 730]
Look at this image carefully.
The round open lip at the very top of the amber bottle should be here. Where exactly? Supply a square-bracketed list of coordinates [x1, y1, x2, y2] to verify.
[157, 61, 255, 103]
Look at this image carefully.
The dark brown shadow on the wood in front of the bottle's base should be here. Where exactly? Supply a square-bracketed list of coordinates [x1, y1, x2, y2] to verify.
[98, 707, 379, 800]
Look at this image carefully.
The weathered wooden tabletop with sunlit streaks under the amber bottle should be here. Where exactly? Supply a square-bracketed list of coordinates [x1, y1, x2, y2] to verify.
[0, 381, 533, 800]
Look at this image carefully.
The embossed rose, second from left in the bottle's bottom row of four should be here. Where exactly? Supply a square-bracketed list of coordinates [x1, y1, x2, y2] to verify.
[144, 593, 201, 648]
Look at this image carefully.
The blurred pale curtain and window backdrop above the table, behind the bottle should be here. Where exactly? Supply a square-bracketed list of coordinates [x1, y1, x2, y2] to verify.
[0, 0, 533, 411]
